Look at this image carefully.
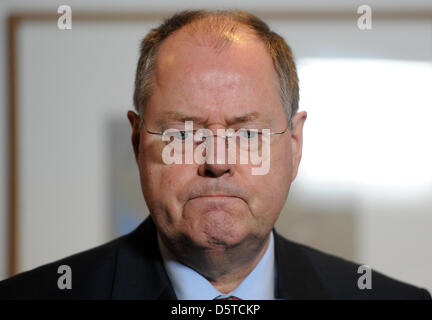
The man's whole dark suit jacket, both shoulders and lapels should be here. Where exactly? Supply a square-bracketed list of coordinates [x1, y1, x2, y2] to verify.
[0, 218, 431, 300]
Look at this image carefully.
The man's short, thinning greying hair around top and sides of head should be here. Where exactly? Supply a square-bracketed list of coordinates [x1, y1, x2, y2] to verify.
[133, 10, 299, 127]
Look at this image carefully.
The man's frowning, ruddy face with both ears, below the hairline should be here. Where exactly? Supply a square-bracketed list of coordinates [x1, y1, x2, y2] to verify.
[129, 32, 305, 250]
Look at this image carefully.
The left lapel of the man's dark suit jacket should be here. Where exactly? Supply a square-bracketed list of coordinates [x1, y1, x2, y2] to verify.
[112, 217, 176, 300]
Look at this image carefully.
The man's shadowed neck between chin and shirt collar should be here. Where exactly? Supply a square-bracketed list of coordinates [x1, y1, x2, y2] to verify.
[158, 234, 270, 293]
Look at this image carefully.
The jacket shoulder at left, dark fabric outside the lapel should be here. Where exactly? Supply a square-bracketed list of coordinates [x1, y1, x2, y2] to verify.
[0, 236, 126, 299]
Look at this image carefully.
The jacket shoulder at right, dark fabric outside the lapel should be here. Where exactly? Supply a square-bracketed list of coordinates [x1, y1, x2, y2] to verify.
[280, 237, 431, 300]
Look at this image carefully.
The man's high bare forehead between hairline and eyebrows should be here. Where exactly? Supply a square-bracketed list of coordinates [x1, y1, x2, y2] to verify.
[148, 30, 282, 124]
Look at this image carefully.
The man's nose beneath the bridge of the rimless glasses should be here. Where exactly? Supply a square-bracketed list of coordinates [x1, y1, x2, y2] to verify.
[198, 136, 234, 178]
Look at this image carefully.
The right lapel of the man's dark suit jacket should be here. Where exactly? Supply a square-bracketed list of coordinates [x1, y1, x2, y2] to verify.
[274, 230, 328, 299]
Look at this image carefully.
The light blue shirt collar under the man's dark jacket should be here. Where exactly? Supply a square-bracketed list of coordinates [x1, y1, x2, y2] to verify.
[158, 232, 275, 300]
